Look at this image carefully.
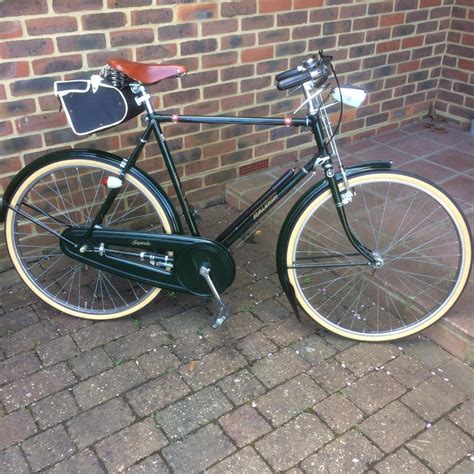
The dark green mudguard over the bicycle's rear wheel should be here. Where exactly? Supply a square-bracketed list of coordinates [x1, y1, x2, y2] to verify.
[0, 149, 183, 234]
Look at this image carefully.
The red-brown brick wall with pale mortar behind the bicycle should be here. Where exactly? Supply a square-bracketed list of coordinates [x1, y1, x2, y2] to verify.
[0, 0, 473, 266]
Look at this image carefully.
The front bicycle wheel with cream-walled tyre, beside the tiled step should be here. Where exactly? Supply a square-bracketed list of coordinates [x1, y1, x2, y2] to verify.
[282, 171, 472, 341]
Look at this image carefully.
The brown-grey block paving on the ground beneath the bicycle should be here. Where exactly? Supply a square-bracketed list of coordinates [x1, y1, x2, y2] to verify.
[0, 128, 474, 474]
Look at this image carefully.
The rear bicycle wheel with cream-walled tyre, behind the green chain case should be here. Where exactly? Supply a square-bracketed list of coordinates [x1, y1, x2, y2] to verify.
[5, 157, 172, 320]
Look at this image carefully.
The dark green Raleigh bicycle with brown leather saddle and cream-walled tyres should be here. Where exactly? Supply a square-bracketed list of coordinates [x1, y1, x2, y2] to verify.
[2, 51, 472, 341]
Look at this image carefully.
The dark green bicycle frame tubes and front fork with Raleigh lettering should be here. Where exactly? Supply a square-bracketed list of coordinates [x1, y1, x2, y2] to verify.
[84, 107, 375, 263]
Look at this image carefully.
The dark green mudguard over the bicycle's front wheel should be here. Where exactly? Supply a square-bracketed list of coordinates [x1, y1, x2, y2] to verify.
[276, 161, 393, 319]
